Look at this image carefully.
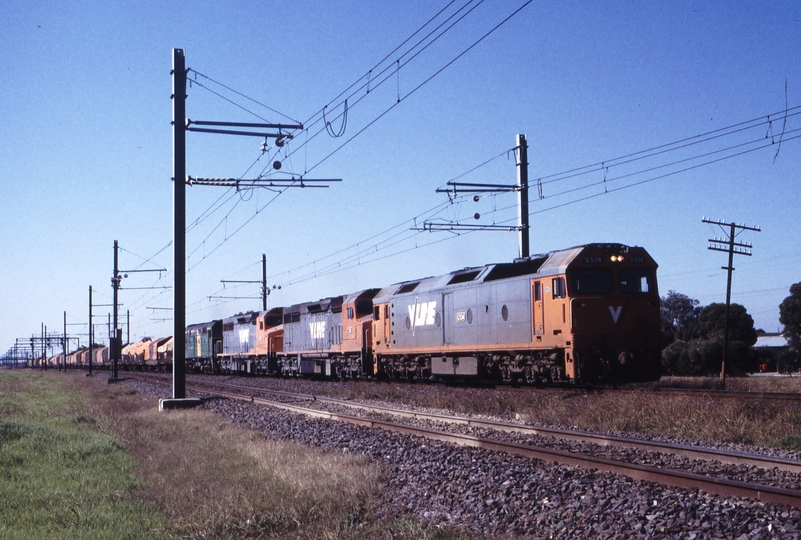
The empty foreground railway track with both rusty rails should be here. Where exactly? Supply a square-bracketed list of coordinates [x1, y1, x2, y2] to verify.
[128, 375, 801, 508]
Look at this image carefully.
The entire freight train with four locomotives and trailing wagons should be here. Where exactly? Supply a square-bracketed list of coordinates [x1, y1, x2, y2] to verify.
[48, 244, 661, 384]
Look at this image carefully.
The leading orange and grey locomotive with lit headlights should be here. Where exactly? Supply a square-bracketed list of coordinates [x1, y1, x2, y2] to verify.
[366, 244, 661, 383]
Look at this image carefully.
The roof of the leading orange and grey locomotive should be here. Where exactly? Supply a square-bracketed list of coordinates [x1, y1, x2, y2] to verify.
[373, 243, 642, 303]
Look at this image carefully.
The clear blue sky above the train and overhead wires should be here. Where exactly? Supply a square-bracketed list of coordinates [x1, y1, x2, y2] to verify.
[0, 0, 801, 354]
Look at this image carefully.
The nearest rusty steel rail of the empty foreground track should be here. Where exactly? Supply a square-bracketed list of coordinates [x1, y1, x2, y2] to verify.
[131, 374, 801, 508]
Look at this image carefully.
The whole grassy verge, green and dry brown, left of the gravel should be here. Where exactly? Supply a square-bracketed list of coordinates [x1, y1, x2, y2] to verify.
[0, 370, 462, 539]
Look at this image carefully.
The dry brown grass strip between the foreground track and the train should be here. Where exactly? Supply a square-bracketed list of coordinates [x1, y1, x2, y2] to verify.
[340, 378, 801, 449]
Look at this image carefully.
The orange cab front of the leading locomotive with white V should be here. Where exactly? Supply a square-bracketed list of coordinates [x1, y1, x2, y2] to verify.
[548, 244, 662, 382]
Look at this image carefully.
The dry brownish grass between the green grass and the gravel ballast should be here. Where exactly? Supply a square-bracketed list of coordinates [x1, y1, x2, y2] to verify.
[65, 377, 467, 539]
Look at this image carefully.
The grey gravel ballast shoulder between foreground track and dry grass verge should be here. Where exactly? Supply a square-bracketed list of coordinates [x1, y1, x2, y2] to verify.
[120, 381, 801, 540]
